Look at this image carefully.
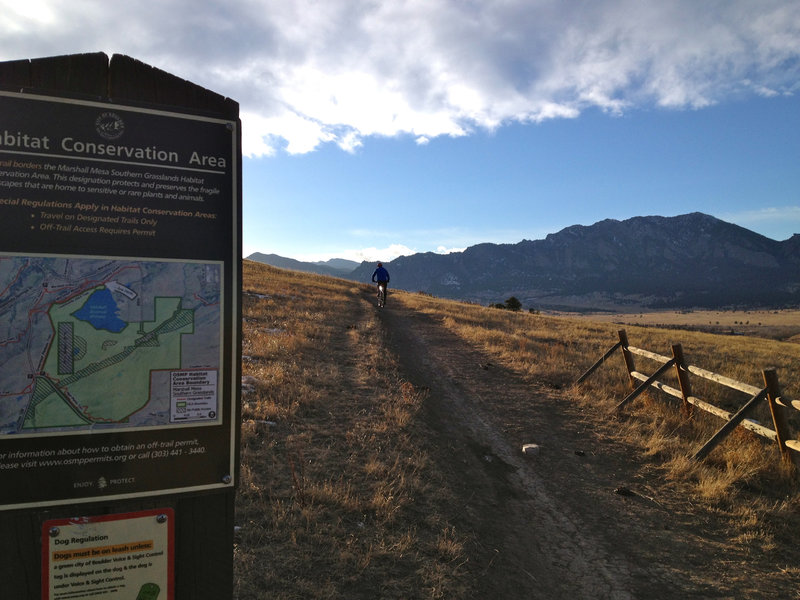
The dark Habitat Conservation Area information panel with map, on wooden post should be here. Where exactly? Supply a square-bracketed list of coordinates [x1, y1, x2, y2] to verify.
[0, 92, 240, 509]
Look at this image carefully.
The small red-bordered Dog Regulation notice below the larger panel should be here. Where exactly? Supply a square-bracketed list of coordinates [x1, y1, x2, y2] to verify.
[42, 508, 175, 600]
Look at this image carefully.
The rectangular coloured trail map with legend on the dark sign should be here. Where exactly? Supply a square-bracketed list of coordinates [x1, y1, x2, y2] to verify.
[0, 254, 222, 435]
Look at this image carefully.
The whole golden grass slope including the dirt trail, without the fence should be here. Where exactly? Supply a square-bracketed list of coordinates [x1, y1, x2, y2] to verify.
[234, 261, 800, 600]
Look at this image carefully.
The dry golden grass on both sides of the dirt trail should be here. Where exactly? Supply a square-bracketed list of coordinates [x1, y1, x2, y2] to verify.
[235, 261, 800, 600]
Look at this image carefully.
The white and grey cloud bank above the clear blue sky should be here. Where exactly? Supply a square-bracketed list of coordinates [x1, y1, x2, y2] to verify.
[0, 0, 800, 156]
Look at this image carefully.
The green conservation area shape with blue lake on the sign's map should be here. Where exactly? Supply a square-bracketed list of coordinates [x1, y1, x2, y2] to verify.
[22, 286, 195, 430]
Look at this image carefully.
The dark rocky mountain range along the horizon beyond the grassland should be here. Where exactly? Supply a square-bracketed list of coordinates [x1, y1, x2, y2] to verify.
[248, 213, 800, 311]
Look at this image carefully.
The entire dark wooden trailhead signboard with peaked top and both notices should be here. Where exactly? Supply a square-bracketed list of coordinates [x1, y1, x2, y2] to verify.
[0, 54, 241, 600]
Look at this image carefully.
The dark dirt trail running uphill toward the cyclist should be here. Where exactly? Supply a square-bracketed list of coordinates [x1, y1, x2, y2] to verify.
[380, 297, 742, 600]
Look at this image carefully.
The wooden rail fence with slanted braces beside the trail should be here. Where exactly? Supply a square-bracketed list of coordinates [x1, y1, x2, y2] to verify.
[576, 329, 800, 467]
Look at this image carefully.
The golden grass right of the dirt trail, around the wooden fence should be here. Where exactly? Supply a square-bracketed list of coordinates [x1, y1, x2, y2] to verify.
[403, 294, 800, 502]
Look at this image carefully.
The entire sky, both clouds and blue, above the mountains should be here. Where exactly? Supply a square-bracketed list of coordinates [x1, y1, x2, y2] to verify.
[0, 0, 800, 261]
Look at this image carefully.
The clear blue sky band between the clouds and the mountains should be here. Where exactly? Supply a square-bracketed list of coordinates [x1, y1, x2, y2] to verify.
[244, 97, 800, 260]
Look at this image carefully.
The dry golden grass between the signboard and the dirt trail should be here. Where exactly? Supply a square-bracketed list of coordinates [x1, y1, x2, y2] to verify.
[235, 261, 472, 600]
